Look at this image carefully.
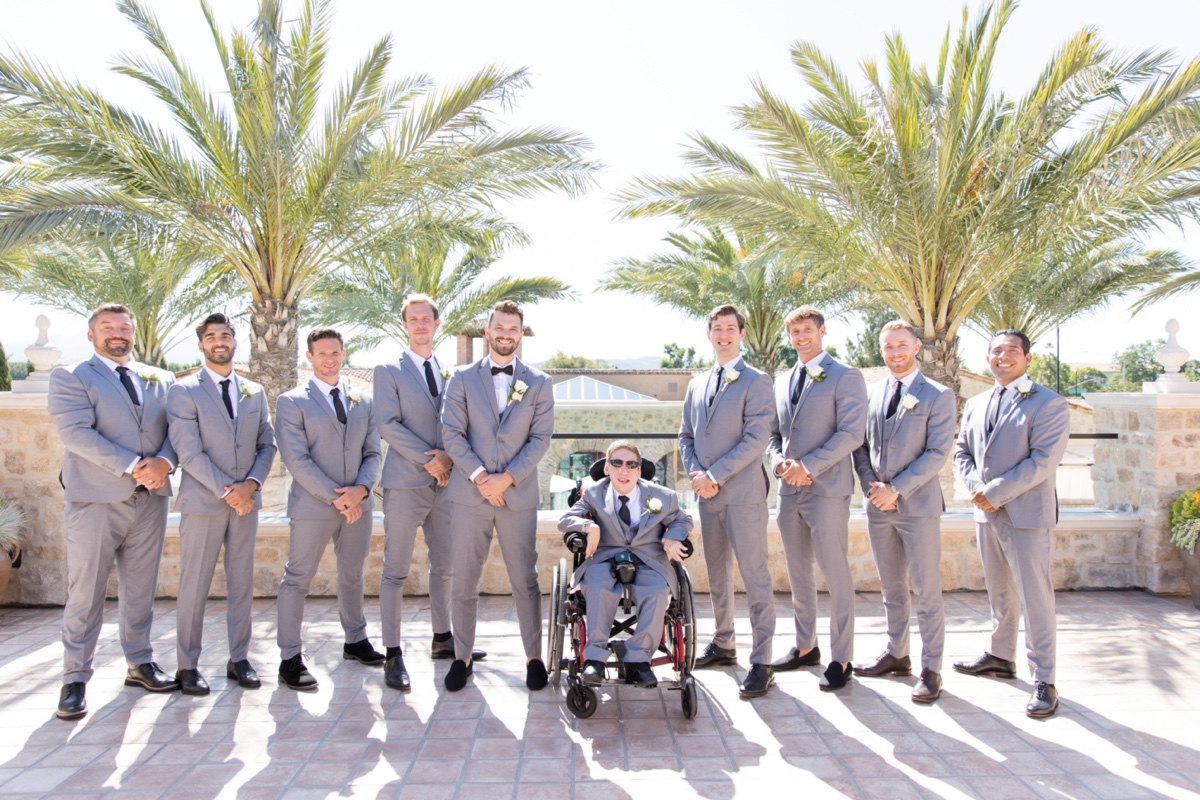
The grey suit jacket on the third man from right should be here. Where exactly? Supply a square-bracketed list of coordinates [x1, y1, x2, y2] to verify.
[767, 354, 866, 498]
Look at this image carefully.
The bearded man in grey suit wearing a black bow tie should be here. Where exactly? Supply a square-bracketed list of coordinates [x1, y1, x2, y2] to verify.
[442, 300, 554, 692]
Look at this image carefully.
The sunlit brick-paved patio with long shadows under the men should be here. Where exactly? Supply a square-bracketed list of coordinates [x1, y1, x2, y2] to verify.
[0, 591, 1200, 800]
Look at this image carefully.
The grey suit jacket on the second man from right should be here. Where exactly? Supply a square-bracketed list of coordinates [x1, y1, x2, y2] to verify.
[854, 372, 958, 517]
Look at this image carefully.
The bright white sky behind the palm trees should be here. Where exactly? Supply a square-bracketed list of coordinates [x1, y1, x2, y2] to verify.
[0, 0, 1200, 376]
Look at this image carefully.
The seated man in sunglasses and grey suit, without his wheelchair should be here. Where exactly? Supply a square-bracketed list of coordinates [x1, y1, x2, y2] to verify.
[558, 439, 692, 688]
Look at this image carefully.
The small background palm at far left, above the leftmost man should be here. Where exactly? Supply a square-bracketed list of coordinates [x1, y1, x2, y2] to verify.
[0, 231, 238, 366]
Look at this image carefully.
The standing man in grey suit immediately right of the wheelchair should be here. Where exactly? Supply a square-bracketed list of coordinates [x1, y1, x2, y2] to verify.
[679, 306, 775, 698]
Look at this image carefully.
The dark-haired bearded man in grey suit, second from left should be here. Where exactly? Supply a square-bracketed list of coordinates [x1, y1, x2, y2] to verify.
[167, 314, 275, 694]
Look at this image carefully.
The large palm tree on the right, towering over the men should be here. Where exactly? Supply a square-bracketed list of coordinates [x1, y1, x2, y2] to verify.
[622, 0, 1200, 407]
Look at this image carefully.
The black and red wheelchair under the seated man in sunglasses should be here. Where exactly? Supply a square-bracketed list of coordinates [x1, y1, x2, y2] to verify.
[546, 458, 700, 720]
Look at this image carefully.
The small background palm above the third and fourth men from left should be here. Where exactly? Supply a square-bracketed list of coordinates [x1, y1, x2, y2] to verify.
[305, 214, 572, 348]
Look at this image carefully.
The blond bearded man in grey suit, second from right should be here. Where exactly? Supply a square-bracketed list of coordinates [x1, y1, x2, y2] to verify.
[854, 319, 958, 703]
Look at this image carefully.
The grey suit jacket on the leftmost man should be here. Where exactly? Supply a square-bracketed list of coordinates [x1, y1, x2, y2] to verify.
[48, 356, 178, 503]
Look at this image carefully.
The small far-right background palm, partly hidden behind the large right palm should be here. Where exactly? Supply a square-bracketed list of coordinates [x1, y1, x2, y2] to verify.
[967, 242, 1186, 342]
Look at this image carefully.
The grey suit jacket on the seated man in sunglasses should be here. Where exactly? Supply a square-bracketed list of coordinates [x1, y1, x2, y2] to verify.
[558, 477, 692, 593]
